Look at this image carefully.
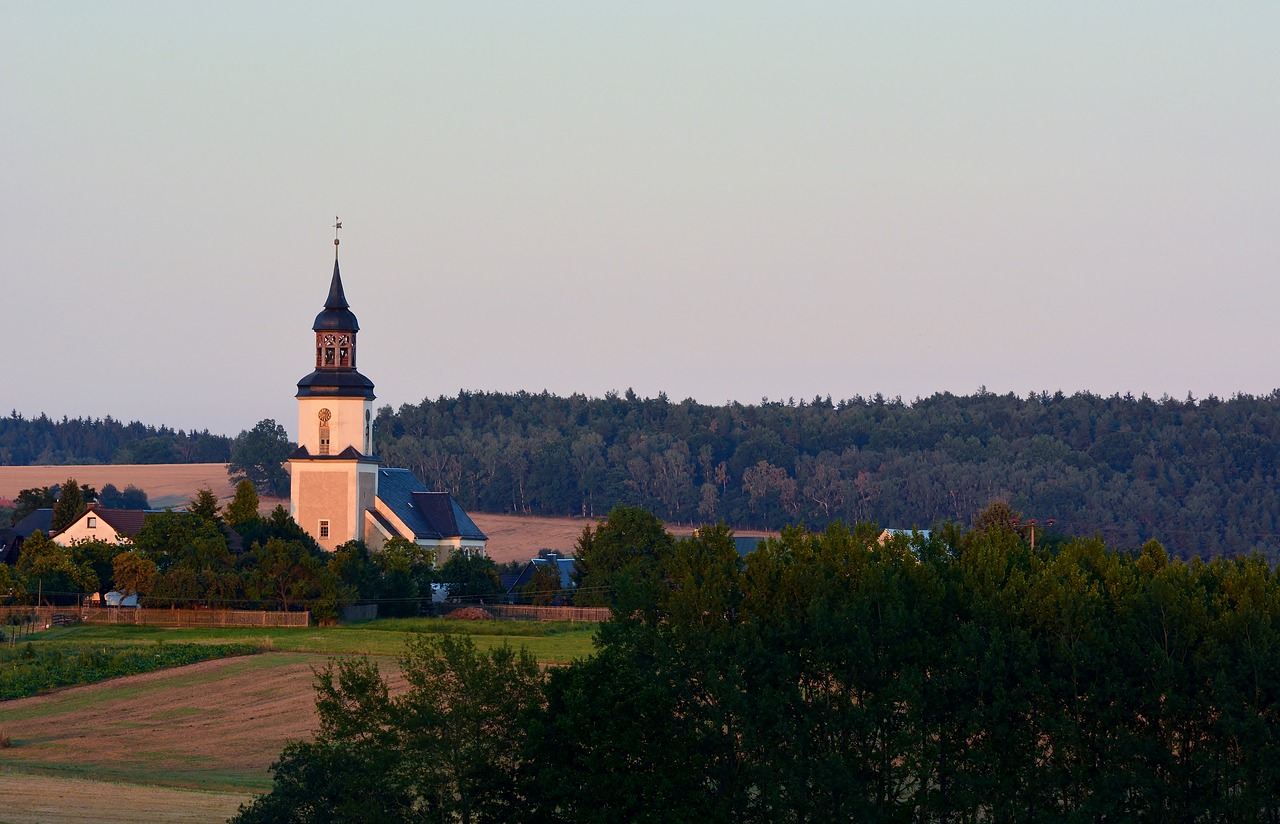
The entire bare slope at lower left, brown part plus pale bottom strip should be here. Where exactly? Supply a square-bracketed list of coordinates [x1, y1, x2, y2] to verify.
[0, 653, 399, 824]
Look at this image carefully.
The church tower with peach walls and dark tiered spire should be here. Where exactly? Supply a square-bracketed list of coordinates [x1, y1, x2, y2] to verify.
[289, 223, 378, 550]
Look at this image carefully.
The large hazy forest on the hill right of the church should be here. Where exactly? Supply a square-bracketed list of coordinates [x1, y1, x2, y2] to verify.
[374, 392, 1280, 563]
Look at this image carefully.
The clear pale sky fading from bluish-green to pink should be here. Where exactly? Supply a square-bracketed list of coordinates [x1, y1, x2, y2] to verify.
[0, 0, 1280, 435]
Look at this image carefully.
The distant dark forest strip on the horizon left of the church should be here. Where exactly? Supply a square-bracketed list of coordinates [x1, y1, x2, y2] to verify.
[0, 411, 230, 466]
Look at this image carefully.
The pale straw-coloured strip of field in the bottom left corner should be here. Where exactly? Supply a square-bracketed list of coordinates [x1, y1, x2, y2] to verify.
[0, 772, 252, 824]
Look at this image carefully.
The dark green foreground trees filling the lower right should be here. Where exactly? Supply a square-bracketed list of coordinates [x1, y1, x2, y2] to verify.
[236, 511, 1280, 824]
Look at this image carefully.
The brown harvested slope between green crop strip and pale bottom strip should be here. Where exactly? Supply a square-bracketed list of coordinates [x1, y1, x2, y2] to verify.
[0, 653, 409, 793]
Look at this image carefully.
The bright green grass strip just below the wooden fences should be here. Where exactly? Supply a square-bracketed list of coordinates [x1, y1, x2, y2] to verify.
[21, 618, 596, 664]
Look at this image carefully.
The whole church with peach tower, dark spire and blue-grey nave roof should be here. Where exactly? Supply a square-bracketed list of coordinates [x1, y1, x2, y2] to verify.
[288, 235, 489, 564]
